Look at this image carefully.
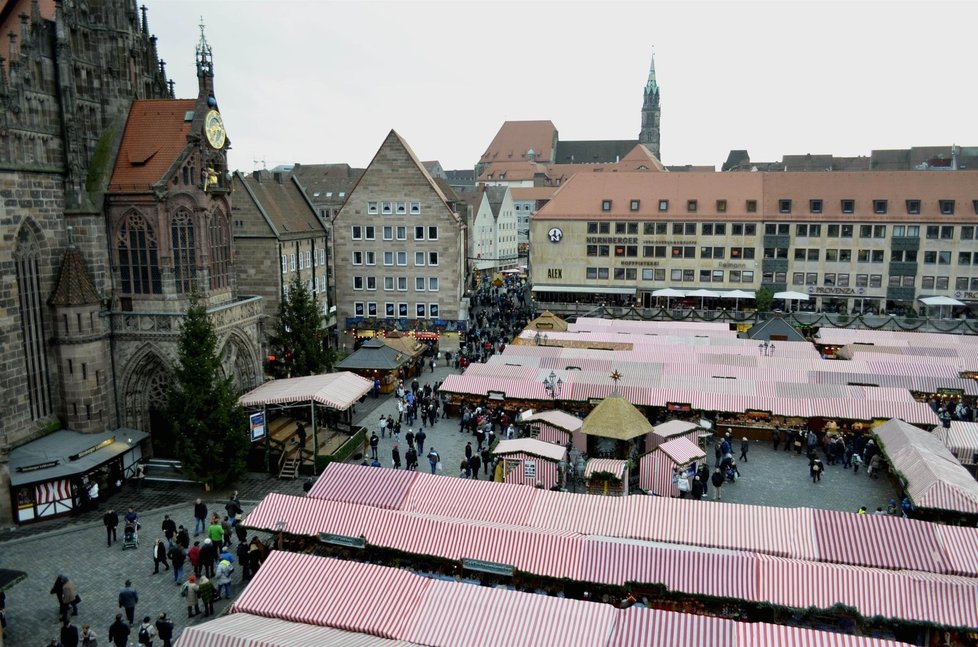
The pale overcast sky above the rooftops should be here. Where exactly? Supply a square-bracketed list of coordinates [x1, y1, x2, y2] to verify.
[145, 0, 978, 171]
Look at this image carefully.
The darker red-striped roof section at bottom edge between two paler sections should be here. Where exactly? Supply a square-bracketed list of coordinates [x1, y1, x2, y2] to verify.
[608, 607, 736, 647]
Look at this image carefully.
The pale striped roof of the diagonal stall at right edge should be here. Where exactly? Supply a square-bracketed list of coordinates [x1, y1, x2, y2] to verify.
[873, 419, 978, 514]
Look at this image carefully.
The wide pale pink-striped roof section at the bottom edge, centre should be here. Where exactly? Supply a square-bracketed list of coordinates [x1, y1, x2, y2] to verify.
[405, 582, 617, 647]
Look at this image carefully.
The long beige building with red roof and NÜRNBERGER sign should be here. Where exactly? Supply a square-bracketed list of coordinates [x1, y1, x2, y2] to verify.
[530, 171, 978, 312]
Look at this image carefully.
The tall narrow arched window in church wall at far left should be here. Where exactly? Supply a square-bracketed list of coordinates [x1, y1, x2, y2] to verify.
[14, 225, 51, 420]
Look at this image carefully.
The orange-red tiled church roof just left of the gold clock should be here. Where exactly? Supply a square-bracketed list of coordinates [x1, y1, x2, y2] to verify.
[109, 99, 197, 192]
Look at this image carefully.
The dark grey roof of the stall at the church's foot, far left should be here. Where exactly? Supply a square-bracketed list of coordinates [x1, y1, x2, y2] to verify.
[9, 427, 149, 486]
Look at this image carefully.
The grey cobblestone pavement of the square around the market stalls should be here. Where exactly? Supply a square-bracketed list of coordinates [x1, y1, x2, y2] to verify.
[0, 360, 895, 646]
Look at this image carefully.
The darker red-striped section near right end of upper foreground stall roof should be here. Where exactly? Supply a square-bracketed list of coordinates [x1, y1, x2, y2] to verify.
[812, 510, 948, 573]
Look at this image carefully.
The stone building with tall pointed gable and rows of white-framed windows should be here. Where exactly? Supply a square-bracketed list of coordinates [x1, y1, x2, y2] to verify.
[332, 130, 466, 331]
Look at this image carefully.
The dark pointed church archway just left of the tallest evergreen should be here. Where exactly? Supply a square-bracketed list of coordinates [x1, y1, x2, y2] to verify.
[123, 350, 176, 457]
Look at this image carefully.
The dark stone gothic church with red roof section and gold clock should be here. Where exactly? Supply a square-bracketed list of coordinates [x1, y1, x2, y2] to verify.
[0, 0, 260, 522]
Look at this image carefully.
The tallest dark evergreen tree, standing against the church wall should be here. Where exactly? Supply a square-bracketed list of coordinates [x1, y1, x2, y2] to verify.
[169, 299, 249, 487]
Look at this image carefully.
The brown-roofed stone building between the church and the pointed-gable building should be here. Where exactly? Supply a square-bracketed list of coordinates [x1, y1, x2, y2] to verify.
[232, 171, 336, 344]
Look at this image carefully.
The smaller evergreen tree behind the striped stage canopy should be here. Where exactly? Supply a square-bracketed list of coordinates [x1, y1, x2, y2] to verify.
[269, 278, 336, 377]
